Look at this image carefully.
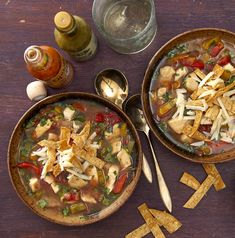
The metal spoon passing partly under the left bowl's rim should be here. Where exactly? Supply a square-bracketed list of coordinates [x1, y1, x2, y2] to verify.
[94, 69, 153, 183]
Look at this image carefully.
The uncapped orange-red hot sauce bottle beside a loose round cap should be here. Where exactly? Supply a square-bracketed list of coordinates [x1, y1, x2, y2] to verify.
[24, 45, 73, 88]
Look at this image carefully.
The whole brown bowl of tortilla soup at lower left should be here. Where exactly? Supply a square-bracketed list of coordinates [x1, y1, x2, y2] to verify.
[8, 93, 142, 226]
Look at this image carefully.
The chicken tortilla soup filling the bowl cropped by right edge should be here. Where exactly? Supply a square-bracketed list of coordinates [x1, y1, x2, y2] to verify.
[149, 37, 235, 156]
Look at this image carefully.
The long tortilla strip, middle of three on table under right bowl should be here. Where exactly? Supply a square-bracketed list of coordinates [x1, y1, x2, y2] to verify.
[183, 175, 215, 209]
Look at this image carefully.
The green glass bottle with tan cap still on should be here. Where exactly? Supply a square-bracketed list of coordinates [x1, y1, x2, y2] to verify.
[54, 11, 97, 61]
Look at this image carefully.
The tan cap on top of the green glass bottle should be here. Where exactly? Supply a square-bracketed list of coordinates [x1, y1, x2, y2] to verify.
[54, 11, 73, 31]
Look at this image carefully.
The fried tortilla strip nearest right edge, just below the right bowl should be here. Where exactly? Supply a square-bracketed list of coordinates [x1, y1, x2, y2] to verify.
[202, 164, 226, 192]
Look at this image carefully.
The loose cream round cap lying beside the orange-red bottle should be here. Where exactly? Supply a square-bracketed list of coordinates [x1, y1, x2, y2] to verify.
[26, 81, 47, 101]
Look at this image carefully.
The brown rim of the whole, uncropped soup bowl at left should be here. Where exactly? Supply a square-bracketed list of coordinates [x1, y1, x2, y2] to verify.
[7, 92, 143, 226]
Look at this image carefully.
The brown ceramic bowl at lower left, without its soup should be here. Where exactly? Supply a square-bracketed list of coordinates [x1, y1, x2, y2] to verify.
[8, 92, 142, 226]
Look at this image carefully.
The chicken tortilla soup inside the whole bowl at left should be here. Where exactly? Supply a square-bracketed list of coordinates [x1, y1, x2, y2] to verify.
[17, 100, 137, 218]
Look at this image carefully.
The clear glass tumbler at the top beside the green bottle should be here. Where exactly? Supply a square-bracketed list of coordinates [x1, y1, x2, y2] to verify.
[92, 0, 157, 54]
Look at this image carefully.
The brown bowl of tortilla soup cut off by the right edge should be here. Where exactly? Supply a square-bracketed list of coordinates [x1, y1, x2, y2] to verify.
[142, 28, 235, 163]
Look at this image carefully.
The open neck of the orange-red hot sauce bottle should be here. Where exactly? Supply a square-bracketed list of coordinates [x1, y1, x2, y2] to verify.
[24, 45, 48, 69]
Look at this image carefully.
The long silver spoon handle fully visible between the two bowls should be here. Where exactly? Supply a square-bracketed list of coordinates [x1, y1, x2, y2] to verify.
[147, 130, 172, 212]
